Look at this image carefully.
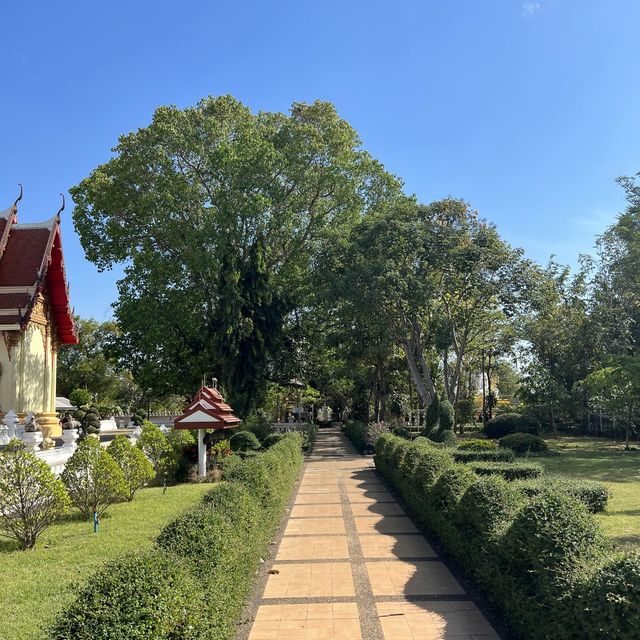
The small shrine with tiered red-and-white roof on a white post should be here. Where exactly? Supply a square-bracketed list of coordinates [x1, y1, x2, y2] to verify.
[173, 381, 241, 476]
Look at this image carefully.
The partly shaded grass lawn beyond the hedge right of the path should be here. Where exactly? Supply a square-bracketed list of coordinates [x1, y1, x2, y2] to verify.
[536, 437, 640, 549]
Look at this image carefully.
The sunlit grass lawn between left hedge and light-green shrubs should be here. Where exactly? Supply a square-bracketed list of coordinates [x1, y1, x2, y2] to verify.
[0, 484, 211, 640]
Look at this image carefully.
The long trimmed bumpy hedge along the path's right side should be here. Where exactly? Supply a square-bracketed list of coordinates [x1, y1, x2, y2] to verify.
[375, 435, 640, 640]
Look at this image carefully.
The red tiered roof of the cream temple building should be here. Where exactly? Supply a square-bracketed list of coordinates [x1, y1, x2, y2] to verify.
[0, 204, 78, 344]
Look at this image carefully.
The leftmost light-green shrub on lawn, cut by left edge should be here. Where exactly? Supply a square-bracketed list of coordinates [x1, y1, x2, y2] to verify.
[0, 439, 71, 549]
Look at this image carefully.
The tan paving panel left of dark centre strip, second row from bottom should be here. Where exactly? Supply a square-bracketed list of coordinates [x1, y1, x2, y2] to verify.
[263, 562, 355, 598]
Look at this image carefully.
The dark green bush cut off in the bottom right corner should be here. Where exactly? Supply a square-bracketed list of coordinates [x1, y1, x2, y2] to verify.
[575, 552, 640, 640]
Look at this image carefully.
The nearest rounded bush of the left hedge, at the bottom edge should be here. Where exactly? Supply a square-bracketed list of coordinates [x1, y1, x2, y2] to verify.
[47, 550, 197, 640]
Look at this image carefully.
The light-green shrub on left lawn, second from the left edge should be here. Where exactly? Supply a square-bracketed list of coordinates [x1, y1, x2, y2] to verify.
[61, 437, 129, 519]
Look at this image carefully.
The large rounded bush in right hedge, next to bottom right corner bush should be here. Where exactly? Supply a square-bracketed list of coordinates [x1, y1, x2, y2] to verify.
[502, 489, 604, 591]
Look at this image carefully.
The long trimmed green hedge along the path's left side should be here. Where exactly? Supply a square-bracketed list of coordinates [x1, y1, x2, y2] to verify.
[47, 433, 302, 640]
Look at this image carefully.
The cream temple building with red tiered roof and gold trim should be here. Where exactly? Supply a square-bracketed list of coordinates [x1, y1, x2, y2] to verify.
[0, 193, 78, 437]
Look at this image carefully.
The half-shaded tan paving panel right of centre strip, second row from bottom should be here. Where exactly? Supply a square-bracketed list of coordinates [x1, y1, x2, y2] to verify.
[366, 560, 465, 596]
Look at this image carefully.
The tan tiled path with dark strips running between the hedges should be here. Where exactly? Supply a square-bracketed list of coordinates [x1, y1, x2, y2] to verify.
[249, 429, 499, 640]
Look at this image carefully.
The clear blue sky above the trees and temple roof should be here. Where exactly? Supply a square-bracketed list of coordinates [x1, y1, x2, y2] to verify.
[0, 0, 640, 319]
